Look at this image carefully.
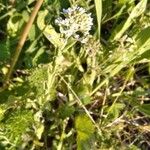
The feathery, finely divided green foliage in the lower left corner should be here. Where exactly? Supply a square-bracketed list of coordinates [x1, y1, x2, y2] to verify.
[0, 110, 33, 147]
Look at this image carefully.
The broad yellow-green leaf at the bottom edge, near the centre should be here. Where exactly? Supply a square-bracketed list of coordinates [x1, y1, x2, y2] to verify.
[75, 114, 95, 150]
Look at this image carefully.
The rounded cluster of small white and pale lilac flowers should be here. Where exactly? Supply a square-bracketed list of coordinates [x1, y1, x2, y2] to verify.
[55, 6, 93, 43]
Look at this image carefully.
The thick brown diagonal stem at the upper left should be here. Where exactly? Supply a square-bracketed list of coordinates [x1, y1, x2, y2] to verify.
[4, 0, 44, 87]
